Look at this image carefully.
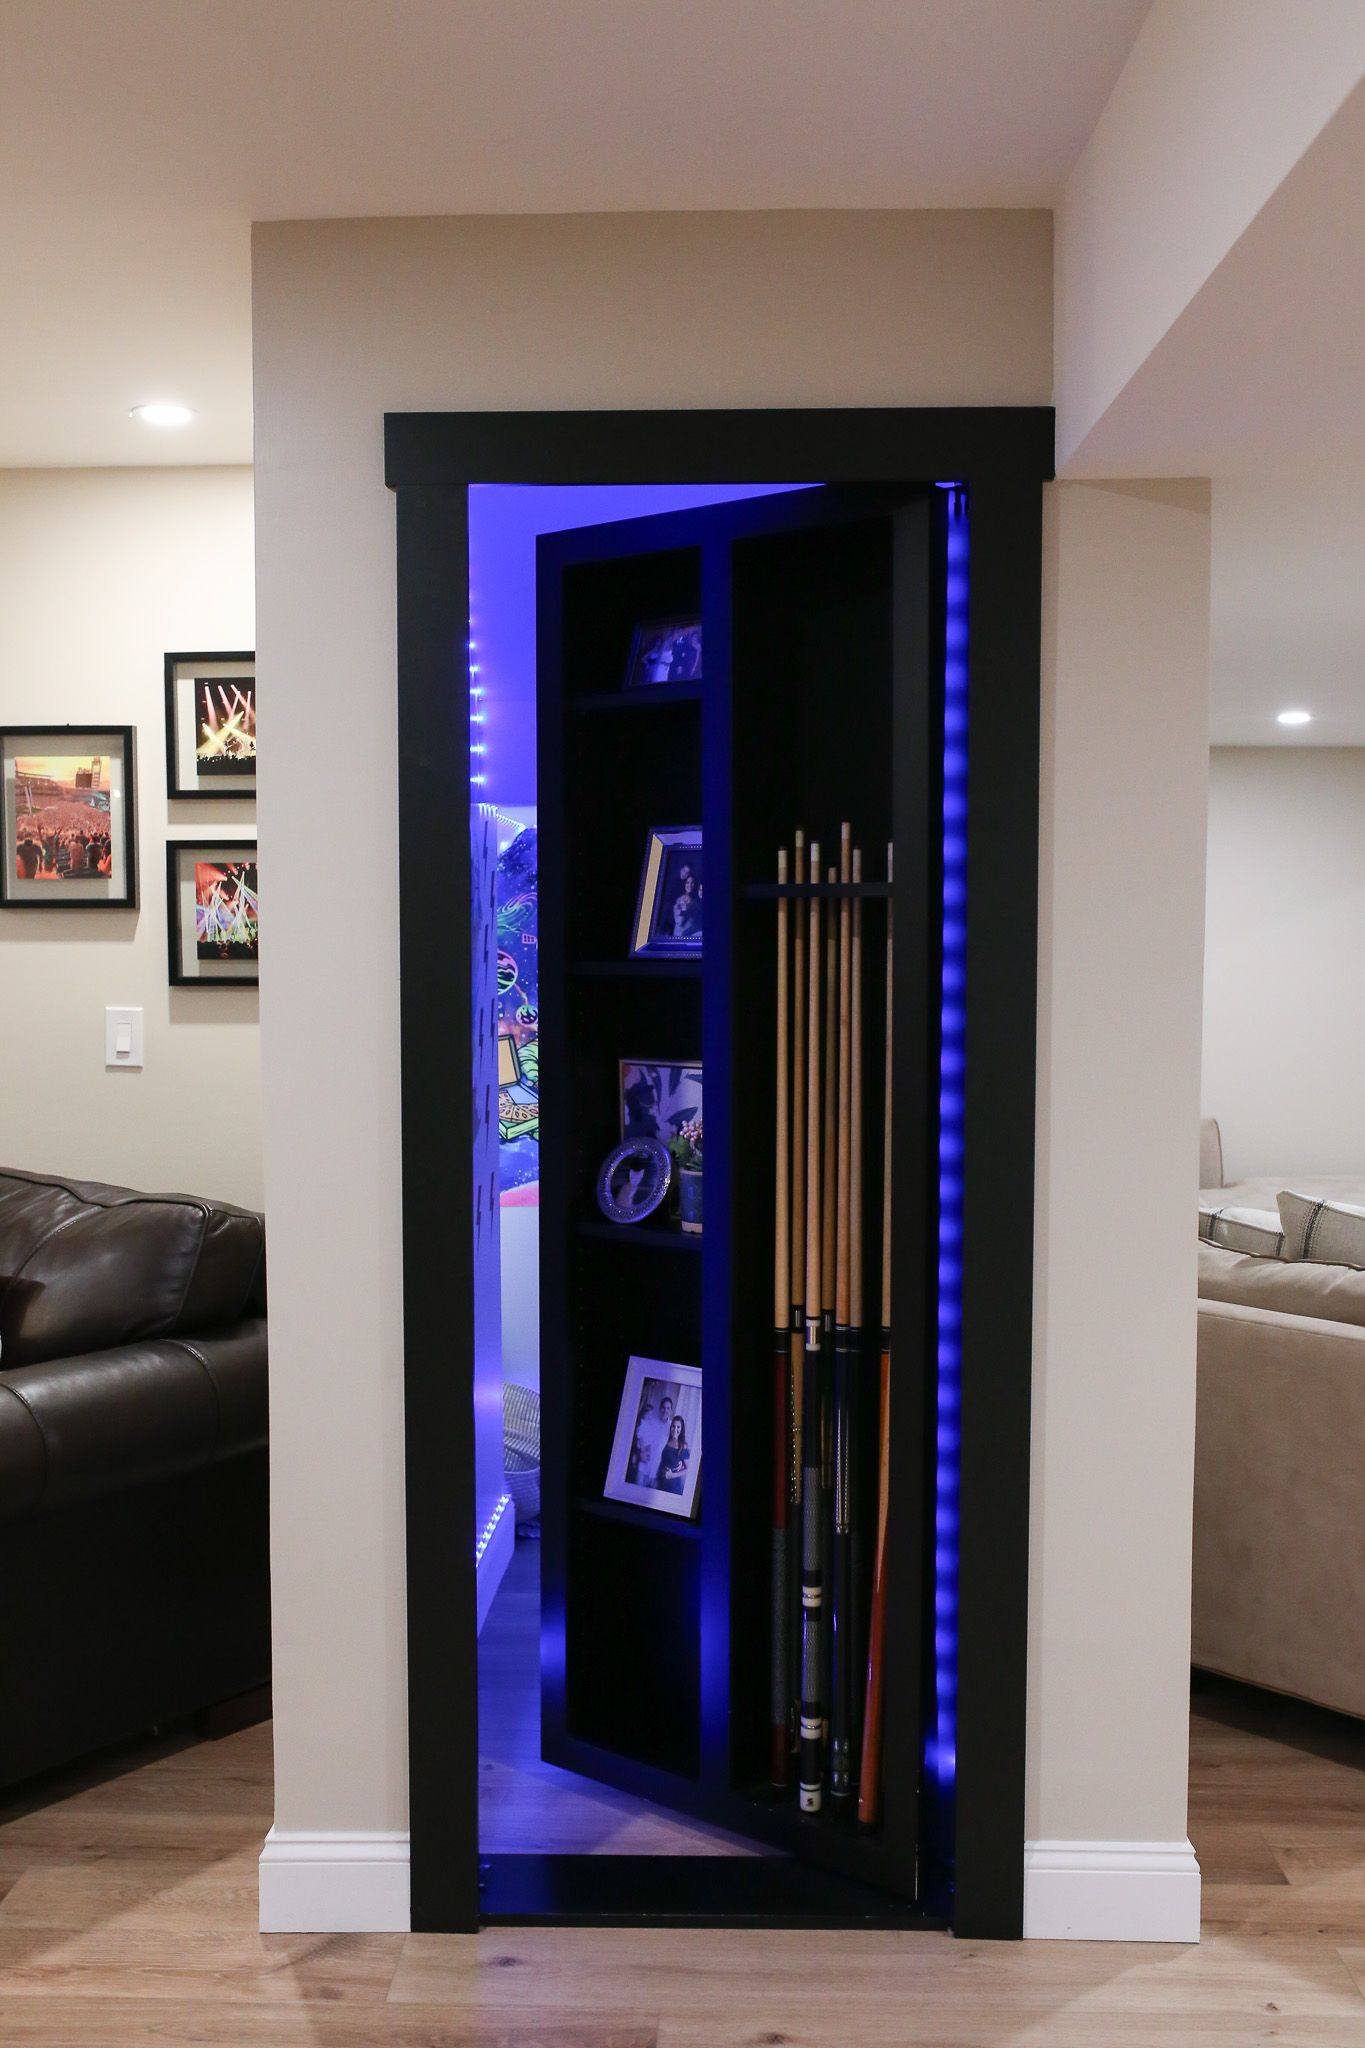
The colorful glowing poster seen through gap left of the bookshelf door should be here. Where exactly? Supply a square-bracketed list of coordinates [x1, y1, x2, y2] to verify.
[495, 825, 540, 1206]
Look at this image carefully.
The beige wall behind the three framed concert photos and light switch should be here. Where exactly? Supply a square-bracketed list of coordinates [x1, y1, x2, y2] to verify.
[0, 469, 262, 1206]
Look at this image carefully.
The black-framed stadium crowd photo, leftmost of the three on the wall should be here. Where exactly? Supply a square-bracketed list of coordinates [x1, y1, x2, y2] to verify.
[0, 725, 137, 909]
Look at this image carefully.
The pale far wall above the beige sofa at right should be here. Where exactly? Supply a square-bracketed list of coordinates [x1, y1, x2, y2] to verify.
[1203, 745, 1365, 1180]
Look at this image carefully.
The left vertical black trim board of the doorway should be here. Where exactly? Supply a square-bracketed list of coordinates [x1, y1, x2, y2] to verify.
[397, 487, 479, 1933]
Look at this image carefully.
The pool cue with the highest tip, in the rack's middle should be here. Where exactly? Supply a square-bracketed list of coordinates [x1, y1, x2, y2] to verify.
[829, 825, 853, 1804]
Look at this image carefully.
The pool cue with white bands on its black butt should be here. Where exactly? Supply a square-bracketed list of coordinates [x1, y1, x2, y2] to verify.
[798, 842, 825, 1812]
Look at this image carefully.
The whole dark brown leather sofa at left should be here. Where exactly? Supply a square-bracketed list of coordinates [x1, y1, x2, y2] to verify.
[0, 1169, 270, 1786]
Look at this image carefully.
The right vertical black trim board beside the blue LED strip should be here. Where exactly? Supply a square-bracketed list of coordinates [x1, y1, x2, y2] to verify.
[954, 475, 1042, 1937]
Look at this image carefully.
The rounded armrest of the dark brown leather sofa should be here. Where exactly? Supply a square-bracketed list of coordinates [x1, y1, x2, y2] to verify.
[0, 1317, 266, 1522]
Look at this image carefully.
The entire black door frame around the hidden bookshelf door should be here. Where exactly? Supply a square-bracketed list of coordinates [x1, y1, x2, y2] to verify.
[385, 408, 1054, 1937]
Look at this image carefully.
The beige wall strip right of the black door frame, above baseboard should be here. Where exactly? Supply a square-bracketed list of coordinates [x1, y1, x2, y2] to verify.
[1027, 483, 1209, 1841]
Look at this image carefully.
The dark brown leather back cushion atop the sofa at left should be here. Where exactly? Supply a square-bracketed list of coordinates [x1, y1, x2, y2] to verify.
[0, 1167, 264, 1368]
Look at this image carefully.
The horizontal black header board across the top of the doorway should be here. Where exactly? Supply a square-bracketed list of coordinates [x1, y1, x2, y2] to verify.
[385, 406, 1054, 489]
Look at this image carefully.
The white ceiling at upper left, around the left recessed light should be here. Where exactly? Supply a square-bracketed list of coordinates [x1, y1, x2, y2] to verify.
[0, 0, 1150, 467]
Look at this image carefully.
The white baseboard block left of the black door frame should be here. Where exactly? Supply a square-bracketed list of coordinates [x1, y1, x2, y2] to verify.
[260, 1827, 411, 1933]
